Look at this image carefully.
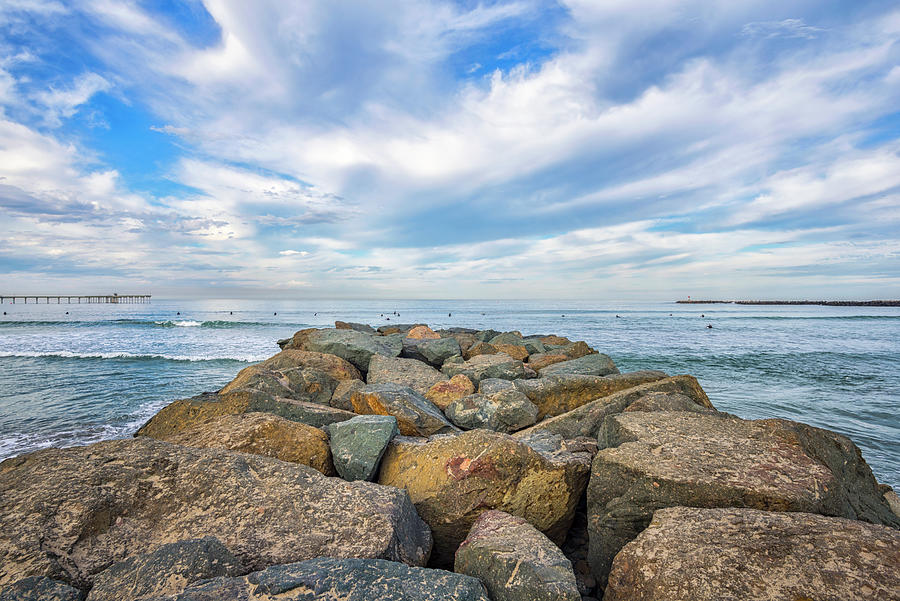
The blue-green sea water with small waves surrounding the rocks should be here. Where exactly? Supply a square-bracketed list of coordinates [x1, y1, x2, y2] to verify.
[0, 299, 900, 487]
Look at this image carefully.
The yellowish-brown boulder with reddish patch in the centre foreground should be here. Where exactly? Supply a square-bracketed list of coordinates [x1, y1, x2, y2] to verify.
[378, 430, 591, 567]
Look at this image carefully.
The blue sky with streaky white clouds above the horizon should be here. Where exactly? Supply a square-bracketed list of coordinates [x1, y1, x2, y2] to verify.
[0, 0, 900, 300]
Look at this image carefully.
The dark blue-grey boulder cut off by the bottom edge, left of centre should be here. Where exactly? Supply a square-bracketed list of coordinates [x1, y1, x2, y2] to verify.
[173, 557, 490, 601]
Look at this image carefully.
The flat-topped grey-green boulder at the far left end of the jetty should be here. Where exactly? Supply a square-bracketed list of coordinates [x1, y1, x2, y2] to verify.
[287, 328, 403, 372]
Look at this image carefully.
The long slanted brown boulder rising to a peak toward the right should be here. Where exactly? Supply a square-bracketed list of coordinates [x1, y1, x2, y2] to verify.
[516, 376, 714, 439]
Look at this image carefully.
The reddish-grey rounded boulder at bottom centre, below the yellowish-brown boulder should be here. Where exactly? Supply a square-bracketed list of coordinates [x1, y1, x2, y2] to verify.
[453, 510, 581, 601]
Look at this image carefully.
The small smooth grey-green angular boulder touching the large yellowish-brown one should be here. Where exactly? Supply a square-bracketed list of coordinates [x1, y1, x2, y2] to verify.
[328, 415, 398, 481]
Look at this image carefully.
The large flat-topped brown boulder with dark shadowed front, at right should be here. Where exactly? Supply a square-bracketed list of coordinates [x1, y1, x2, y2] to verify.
[587, 411, 900, 583]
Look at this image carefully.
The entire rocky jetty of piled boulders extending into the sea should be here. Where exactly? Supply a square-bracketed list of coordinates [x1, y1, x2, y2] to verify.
[0, 322, 900, 601]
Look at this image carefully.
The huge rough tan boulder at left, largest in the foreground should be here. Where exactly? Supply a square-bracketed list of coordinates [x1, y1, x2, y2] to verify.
[0, 438, 431, 588]
